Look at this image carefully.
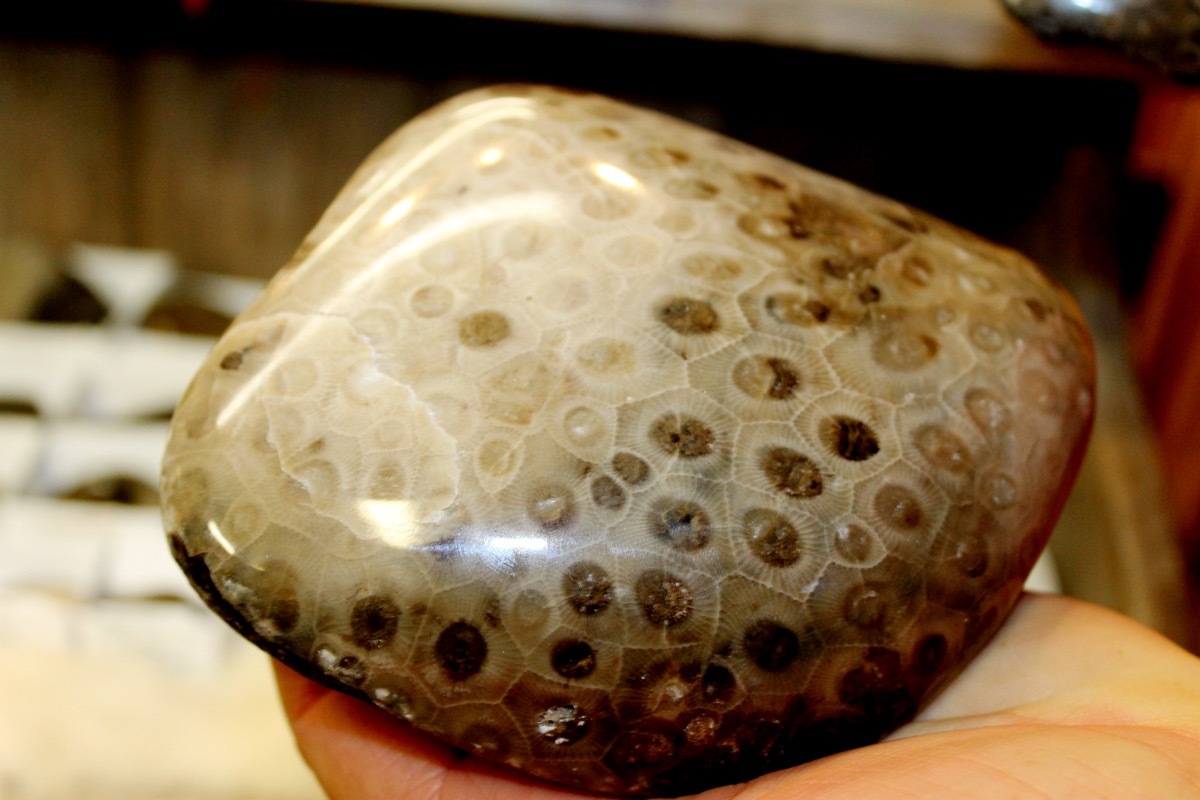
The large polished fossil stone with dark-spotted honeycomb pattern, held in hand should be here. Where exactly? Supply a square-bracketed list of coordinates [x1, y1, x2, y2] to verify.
[163, 88, 1093, 794]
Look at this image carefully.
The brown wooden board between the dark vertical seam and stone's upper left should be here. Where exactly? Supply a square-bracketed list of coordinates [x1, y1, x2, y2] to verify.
[131, 54, 421, 276]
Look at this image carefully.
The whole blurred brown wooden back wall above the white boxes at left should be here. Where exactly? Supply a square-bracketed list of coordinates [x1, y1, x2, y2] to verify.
[0, 42, 431, 276]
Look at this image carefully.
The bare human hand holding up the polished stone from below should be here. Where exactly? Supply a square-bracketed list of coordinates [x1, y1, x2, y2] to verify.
[275, 595, 1200, 800]
